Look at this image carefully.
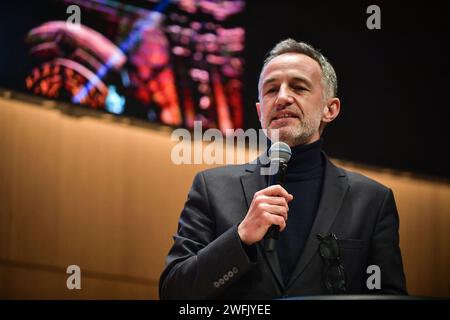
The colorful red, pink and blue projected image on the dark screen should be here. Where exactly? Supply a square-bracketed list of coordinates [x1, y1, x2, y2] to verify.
[25, 0, 245, 132]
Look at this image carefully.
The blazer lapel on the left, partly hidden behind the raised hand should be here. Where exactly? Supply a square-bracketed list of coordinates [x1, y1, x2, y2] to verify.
[241, 164, 284, 288]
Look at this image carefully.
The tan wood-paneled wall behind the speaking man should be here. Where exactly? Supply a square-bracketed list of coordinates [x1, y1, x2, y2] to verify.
[0, 98, 450, 299]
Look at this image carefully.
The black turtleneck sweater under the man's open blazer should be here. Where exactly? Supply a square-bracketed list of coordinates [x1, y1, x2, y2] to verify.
[277, 139, 324, 283]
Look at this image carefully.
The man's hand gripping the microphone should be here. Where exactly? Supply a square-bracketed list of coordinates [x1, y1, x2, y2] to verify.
[238, 185, 294, 245]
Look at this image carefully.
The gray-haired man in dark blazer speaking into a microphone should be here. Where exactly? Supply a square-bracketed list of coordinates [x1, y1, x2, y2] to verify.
[159, 39, 406, 299]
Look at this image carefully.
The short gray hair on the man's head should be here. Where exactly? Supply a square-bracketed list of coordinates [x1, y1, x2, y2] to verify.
[258, 39, 337, 99]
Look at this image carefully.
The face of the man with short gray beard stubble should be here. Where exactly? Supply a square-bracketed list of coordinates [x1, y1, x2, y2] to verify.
[256, 53, 326, 147]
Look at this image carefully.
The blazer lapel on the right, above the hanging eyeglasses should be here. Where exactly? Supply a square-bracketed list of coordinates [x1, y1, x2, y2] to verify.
[287, 154, 349, 289]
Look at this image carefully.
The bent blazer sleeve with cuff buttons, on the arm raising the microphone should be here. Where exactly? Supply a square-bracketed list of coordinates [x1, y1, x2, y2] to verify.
[159, 172, 254, 299]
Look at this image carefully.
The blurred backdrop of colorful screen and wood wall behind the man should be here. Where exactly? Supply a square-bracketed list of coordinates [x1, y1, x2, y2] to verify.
[0, 0, 450, 299]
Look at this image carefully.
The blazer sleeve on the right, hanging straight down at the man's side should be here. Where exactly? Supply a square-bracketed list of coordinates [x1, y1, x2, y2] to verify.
[368, 189, 407, 294]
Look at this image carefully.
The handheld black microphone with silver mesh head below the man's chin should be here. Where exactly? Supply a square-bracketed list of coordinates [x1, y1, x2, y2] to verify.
[264, 142, 292, 251]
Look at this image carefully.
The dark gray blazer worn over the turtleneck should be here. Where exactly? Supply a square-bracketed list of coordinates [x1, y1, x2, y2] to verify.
[159, 158, 406, 299]
